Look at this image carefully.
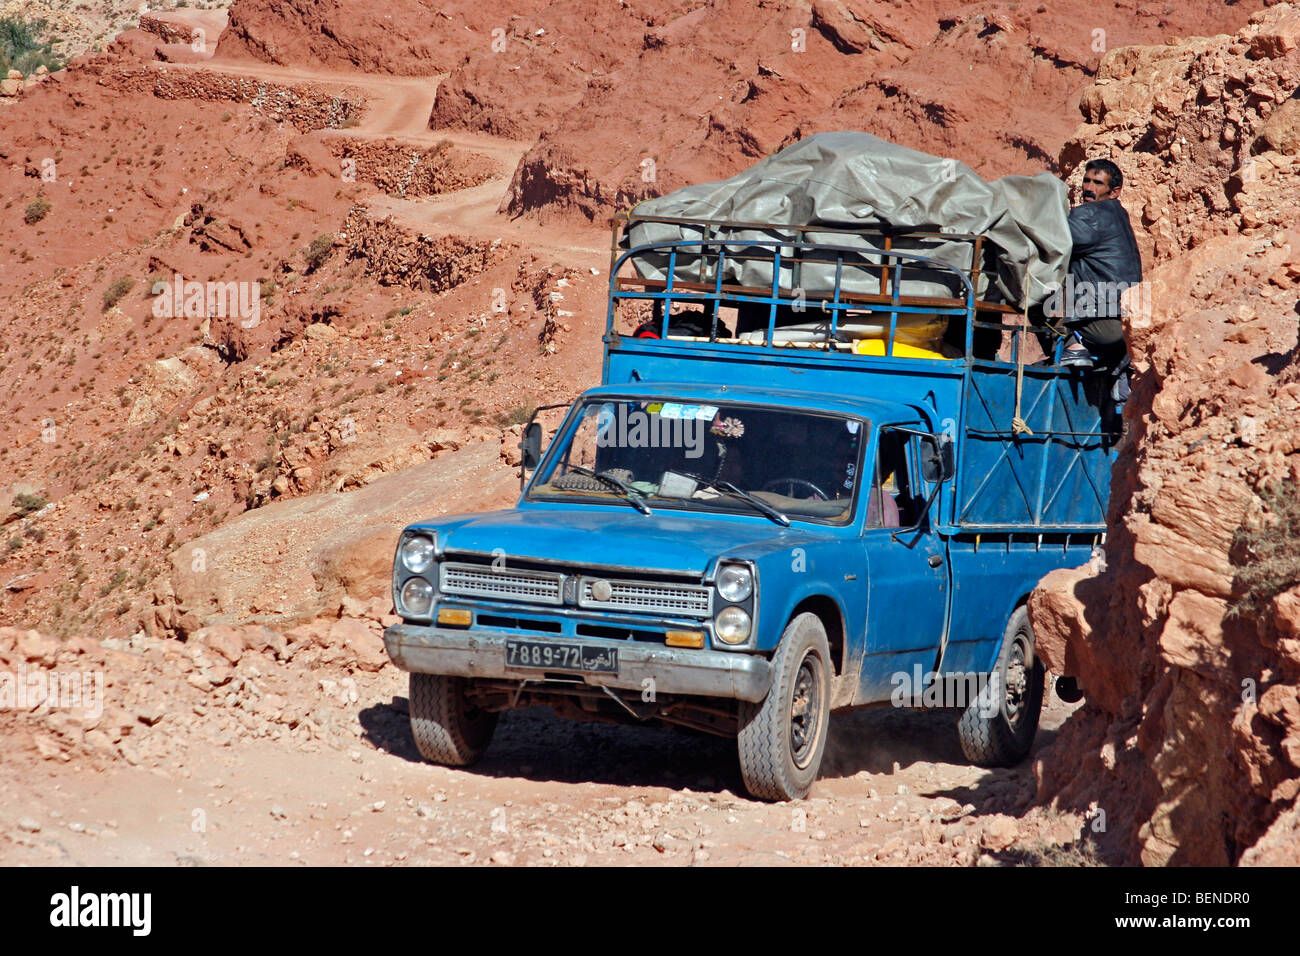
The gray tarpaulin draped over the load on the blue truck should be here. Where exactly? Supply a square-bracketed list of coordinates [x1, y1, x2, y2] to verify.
[623, 131, 1070, 308]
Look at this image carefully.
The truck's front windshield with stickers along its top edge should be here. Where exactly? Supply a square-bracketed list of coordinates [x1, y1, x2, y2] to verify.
[529, 398, 867, 524]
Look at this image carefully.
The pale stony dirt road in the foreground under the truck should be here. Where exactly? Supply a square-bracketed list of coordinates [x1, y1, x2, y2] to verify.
[0, 658, 1079, 866]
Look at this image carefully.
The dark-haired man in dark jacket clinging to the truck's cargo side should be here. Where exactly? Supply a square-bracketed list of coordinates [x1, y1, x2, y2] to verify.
[1045, 159, 1141, 371]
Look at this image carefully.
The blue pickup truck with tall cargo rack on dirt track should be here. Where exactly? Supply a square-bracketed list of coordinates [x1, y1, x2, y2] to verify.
[385, 217, 1118, 800]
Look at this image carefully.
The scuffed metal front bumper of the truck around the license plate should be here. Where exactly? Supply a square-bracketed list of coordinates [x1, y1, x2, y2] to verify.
[384, 624, 772, 704]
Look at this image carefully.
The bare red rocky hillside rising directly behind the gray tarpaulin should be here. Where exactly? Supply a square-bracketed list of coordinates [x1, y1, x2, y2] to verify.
[499, 0, 1258, 221]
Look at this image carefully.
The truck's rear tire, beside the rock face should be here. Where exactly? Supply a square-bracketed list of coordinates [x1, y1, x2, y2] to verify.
[957, 605, 1045, 767]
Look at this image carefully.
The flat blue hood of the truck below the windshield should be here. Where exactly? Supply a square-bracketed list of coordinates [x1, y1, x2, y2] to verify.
[417, 507, 828, 575]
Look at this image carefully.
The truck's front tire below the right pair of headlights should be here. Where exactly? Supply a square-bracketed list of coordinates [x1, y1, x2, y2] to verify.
[737, 614, 832, 800]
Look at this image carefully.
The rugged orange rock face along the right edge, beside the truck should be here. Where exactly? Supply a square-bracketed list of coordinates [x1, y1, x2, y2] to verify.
[1030, 5, 1300, 865]
